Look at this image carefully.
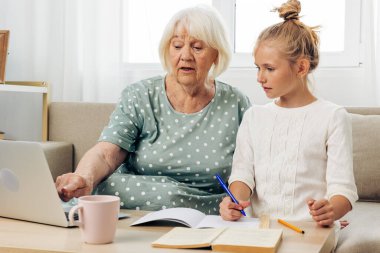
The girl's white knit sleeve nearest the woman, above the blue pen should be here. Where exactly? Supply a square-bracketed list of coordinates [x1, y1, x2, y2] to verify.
[228, 108, 255, 192]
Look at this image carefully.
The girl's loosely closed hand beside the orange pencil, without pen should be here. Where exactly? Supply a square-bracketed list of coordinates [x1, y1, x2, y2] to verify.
[307, 199, 335, 226]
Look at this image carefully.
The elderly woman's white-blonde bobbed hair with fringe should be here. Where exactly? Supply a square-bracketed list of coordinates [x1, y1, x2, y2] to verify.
[159, 5, 231, 78]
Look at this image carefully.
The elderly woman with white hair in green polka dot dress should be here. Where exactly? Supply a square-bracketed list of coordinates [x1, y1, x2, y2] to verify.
[56, 6, 250, 214]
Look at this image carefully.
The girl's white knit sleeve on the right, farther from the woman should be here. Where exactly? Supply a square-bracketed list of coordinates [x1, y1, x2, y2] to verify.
[326, 108, 358, 206]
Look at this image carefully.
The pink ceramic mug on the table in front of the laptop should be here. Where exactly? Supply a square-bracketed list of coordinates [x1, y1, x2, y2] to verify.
[69, 195, 120, 244]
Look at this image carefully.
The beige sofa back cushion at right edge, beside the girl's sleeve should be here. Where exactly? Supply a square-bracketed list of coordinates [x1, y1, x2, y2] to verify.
[351, 114, 380, 201]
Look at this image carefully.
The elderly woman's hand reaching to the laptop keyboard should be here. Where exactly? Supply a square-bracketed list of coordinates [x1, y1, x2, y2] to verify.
[55, 173, 93, 201]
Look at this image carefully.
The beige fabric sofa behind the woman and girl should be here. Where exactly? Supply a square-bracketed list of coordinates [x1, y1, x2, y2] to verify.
[43, 102, 380, 253]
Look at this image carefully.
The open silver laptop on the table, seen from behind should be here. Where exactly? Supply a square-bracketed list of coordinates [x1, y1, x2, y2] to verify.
[0, 140, 125, 227]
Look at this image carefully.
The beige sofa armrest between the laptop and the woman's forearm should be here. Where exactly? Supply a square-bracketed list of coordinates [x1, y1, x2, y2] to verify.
[41, 141, 74, 181]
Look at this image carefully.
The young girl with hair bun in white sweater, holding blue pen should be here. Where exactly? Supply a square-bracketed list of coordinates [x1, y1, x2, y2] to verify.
[220, 0, 358, 233]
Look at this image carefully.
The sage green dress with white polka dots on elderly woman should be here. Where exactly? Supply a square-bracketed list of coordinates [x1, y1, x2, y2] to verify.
[97, 77, 250, 214]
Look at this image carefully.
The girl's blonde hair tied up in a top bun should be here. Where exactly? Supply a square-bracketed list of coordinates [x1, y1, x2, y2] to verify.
[255, 0, 319, 73]
